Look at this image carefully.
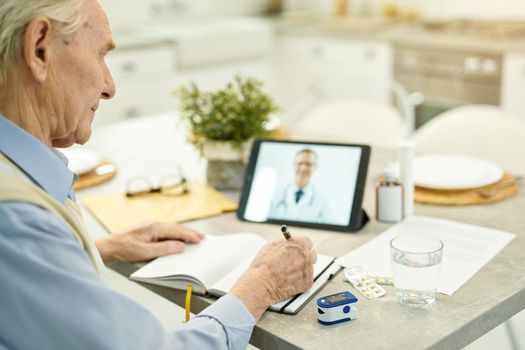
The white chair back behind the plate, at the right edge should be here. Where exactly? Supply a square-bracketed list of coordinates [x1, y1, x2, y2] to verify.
[414, 105, 525, 175]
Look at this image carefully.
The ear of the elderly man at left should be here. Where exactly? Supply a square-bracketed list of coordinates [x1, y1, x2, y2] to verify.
[22, 17, 52, 82]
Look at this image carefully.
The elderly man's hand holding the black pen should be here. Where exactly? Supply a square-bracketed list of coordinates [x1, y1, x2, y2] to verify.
[230, 237, 317, 320]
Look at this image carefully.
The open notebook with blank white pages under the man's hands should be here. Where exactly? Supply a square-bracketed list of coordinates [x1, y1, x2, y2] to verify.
[130, 233, 340, 314]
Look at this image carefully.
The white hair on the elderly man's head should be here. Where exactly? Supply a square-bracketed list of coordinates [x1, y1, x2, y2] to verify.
[0, 0, 85, 85]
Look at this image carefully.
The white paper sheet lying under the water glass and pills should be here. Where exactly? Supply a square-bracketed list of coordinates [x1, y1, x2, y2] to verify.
[336, 216, 516, 295]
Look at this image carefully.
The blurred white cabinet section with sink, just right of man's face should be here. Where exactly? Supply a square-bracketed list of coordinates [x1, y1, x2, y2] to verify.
[95, 18, 273, 126]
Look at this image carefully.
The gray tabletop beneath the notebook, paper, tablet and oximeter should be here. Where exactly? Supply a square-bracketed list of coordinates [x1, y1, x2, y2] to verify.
[106, 150, 525, 350]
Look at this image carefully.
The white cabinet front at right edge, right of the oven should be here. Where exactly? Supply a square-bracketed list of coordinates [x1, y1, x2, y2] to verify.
[501, 53, 525, 118]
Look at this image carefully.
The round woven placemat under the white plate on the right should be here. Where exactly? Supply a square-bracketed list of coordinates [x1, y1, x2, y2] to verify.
[415, 174, 518, 205]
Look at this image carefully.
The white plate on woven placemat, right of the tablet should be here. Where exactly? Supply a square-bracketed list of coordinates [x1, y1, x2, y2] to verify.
[414, 154, 503, 190]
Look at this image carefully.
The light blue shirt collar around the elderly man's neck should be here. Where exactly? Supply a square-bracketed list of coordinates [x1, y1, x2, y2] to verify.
[0, 115, 76, 203]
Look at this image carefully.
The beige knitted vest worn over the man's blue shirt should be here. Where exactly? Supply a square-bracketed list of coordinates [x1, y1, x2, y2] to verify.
[0, 153, 105, 276]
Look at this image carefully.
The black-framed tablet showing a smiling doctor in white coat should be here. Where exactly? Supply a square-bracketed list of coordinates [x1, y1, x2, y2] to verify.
[237, 139, 370, 231]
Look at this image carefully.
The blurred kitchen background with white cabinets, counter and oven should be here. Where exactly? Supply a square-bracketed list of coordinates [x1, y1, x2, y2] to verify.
[95, 0, 525, 349]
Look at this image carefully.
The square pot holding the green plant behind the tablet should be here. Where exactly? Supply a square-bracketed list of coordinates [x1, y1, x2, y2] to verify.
[202, 140, 251, 190]
